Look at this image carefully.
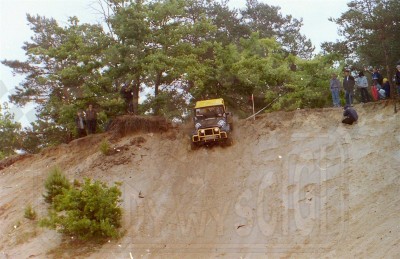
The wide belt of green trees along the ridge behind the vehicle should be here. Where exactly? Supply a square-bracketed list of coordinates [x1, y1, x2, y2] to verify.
[0, 0, 344, 134]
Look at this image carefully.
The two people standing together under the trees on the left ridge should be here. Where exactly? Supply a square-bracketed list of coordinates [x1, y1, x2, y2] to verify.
[75, 104, 97, 138]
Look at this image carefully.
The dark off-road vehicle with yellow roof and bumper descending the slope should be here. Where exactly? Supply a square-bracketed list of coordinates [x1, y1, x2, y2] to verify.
[191, 98, 232, 150]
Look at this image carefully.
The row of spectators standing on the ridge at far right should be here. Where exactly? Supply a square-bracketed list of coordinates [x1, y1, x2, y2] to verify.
[330, 64, 400, 107]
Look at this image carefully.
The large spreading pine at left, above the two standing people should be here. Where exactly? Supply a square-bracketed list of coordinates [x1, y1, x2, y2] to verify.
[2, 14, 112, 149]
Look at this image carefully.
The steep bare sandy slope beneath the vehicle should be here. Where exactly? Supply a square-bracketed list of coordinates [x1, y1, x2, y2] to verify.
[0, 102, 400, 258]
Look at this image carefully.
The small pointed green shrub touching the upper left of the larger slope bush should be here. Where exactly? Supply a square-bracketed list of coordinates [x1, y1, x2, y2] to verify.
[43, 167, 71, 203]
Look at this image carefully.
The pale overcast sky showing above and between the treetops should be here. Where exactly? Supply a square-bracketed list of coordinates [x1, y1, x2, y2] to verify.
[0, 0, 350, 125]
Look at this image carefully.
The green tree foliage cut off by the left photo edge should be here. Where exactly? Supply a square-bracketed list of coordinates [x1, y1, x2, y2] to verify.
[0, 103, 21, 160]
